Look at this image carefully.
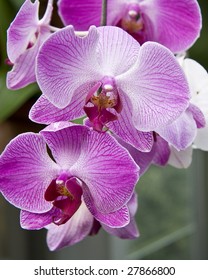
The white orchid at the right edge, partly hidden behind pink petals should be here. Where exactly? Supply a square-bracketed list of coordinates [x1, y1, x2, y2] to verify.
[169, 56, 208, 168]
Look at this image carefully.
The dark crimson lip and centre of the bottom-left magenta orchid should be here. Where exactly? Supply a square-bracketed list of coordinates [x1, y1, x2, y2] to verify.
[45, 174, 82, 225]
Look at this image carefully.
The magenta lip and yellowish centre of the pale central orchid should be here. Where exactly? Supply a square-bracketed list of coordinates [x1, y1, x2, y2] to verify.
[84, 77, 122, 131]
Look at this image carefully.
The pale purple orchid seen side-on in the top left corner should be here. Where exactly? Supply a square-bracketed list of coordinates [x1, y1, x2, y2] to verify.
[7, 0, 53, 89]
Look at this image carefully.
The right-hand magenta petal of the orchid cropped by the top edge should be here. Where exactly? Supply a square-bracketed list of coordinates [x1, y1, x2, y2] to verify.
[139, 0, 202, 52]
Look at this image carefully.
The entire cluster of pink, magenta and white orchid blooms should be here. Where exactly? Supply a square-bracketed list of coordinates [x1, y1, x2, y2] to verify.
[0, 0, 208, 250]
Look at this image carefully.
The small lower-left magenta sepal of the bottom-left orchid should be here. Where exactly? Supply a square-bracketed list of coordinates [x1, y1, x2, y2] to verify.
[20, 207, 61, 230]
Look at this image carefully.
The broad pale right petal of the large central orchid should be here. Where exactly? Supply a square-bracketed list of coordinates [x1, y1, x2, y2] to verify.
[116, 42, 189, 131]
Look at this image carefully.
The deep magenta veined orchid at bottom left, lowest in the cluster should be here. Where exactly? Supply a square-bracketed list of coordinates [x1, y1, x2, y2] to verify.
[0, 122, 139, 248]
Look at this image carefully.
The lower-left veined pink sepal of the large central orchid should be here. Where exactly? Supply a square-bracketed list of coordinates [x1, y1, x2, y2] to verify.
[29, 81, 92, 124]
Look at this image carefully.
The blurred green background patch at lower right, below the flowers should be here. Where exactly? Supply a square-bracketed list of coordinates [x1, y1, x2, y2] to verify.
[129, 166, 194, 259]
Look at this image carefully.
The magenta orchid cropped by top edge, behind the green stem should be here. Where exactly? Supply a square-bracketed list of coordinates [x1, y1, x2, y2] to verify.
[58, 0, 202, 52]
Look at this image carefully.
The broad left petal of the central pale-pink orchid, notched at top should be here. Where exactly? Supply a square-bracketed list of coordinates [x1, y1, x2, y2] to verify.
[37, 26, 100, 108]
